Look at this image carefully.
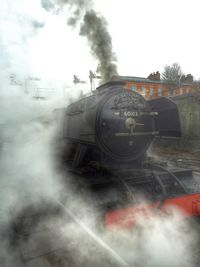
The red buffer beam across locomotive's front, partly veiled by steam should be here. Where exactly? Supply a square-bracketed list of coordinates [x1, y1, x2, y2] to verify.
[105, 193, 200, 228]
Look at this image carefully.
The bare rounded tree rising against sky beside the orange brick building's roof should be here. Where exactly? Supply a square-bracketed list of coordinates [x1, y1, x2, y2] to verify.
[162, 63, 183, 84]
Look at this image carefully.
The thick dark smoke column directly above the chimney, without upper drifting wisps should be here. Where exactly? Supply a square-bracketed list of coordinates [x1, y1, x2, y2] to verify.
[80, 10, 117, 82]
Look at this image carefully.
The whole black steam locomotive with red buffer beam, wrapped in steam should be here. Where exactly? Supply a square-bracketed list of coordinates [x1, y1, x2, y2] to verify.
[55, 81, 200, 227]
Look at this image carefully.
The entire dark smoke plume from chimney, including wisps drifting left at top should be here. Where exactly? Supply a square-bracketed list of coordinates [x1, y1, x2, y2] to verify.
[41, 0, 117, 82]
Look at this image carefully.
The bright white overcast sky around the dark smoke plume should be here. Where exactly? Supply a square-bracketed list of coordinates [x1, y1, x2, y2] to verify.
[0, 0, 200, 89]
